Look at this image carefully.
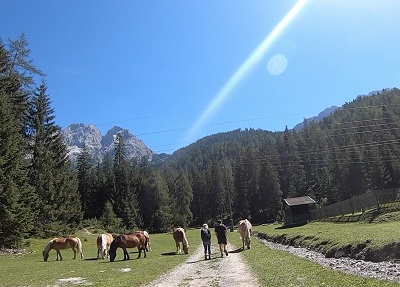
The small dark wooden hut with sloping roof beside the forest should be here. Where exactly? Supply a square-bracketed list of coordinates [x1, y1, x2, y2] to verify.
[284, 196, 315, 225]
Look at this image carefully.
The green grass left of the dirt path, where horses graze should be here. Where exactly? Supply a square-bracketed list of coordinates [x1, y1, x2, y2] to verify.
[0, 230, 200, 286]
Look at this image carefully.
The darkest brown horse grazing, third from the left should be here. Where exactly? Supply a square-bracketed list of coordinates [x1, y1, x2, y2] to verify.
[109, 232, 147, 262]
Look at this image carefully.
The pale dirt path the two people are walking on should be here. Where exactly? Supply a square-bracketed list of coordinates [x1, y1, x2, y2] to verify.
[144, 245, 259, 287]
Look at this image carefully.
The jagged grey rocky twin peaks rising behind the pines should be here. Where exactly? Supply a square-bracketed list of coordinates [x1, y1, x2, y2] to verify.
[62, 124, 154, 162]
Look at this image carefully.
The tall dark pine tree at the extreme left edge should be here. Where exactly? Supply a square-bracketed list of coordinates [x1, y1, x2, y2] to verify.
[0, 39, 36, 247]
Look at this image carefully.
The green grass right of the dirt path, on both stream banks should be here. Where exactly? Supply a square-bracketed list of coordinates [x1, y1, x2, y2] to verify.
[228, 223, 400, 287]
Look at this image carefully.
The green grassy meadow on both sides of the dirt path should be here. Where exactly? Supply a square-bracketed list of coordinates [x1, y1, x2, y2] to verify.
[0, 215, 400, 287]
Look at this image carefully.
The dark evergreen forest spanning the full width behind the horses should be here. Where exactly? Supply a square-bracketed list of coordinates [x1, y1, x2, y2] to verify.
[0, 35, 400, 247]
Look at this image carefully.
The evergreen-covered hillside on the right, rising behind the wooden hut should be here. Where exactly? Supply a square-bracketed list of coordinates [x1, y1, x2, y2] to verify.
[164, 88, 400, 227]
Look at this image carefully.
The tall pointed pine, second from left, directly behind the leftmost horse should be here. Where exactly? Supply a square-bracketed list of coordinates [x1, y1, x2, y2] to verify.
[29, 81, 81, 236]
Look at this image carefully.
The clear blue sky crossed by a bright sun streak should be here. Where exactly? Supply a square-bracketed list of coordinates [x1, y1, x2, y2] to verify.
[0, 0, 400, 153]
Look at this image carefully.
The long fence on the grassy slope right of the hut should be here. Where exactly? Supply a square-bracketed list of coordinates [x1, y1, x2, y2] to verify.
[311, 188, 400, 220]
